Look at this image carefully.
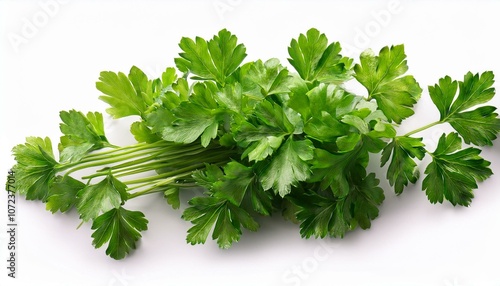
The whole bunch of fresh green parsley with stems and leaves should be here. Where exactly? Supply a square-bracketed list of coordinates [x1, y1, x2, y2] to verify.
[9, 29, 500, 259]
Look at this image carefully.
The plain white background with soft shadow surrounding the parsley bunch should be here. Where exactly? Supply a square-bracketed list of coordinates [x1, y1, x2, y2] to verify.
[0, 0, 500, 286]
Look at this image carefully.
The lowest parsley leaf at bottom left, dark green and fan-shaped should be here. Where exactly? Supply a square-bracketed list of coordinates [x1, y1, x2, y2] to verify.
[92, 207, 148, 260]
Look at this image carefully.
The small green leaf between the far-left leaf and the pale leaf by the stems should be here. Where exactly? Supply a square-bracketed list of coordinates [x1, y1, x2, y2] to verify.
[46, 176, 85, 213]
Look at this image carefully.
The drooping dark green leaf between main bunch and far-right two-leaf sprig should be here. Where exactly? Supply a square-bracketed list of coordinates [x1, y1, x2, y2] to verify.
[381, 136, 425, 194]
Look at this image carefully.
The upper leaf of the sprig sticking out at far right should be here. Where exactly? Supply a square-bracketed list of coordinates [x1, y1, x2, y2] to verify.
[429, 72, 500, 146]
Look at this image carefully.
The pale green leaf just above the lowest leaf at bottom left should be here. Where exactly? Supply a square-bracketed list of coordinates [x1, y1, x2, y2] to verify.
[77, 173, 128, 221]
